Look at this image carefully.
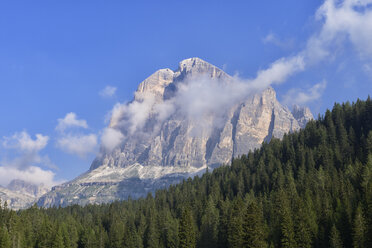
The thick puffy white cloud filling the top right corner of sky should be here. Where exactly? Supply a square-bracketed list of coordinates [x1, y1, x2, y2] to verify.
[306, 0, 372, 62]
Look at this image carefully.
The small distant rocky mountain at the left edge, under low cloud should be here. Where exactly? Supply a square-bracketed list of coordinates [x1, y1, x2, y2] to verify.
[0, 179, 49, 209]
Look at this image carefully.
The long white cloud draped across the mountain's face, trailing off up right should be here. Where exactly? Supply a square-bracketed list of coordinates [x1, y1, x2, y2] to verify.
[105, 55, 305, 140]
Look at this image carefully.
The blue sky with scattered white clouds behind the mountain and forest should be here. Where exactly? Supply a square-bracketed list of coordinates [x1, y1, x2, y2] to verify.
[0, 0, 372, 185]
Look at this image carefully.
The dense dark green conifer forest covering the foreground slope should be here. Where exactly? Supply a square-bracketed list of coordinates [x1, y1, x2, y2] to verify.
[0, 98, 372, 248]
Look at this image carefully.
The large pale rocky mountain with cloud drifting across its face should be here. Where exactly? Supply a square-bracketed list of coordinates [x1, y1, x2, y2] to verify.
[38, 58, 312, 206]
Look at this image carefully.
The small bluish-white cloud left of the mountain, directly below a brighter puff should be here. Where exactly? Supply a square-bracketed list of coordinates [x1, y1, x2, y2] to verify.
[57, 134, 97, 158]
